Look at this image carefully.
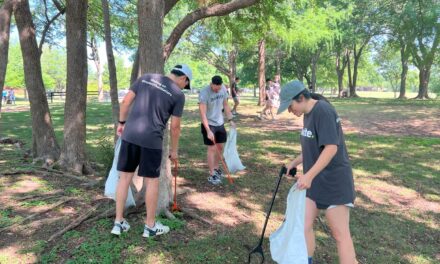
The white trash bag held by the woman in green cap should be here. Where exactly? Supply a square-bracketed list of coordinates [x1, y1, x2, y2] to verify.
[269, 184, 308, 264]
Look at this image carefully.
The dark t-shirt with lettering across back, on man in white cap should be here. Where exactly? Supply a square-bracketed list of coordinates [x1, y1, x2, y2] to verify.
[122, 74, 185, 149]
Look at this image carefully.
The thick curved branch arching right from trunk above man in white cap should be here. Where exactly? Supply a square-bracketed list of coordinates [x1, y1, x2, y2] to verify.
[163, 0, 259, 60]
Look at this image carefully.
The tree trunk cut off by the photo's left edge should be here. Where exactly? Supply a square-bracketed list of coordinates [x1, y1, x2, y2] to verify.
[0, 0, 13, 118]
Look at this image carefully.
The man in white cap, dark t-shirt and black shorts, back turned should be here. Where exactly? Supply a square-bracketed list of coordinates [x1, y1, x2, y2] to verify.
[111, 64, 192, 237]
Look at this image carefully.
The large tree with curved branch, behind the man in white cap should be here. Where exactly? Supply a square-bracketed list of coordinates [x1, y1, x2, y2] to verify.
[137, 0, 258, 212]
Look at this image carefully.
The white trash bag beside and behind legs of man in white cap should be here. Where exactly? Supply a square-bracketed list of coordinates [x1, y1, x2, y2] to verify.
[104, 138, 136, 208]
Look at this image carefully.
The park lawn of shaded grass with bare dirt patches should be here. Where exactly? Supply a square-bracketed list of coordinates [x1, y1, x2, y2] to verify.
[0, 96, 440, 264]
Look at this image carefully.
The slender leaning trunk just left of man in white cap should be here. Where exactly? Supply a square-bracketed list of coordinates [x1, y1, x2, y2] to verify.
[101, 0, 119, 140]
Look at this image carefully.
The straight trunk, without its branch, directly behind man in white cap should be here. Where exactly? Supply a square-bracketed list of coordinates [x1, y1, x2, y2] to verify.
[138, 0, 172, 214]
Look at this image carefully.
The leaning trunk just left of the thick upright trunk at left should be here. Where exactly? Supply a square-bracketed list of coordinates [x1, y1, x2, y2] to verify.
[14, 0, 60, 164]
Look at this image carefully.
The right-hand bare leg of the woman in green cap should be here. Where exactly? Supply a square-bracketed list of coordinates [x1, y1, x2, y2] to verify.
[325, 205, 357, 264]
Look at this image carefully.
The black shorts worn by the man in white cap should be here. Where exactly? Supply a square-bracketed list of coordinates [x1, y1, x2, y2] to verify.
[117, 140, 162, 178]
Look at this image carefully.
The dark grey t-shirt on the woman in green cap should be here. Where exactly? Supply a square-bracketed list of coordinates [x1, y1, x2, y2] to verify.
[300, 100, 355, 205]
